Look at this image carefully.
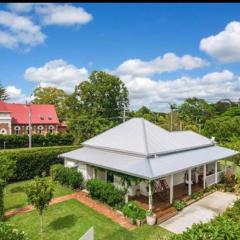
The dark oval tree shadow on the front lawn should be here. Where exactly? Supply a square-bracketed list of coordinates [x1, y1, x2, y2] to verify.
[49, 214, 78, 230]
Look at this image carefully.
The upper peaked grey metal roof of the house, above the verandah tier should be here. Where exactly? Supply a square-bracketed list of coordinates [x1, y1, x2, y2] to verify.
[83, 118, 214, 156]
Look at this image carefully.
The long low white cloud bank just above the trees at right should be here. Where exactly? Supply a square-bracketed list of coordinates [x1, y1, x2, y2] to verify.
[120, 70, 240, 111]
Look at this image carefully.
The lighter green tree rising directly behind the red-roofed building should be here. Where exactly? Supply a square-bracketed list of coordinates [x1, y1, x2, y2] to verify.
[33, 87, 68, 120]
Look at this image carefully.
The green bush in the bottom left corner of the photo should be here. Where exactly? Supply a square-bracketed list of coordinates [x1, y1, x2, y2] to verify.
[0, 222, 28, 240]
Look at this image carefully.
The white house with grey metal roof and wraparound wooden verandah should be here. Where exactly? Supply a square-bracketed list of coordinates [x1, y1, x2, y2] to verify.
[61, 118, 237, 216]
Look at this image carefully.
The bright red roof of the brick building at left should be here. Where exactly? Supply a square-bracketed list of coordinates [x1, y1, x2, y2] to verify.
[0, 103, 59, 124]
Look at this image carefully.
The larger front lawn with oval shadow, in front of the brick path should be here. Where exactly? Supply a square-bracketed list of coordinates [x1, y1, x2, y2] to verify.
[8, 199, 172, 240]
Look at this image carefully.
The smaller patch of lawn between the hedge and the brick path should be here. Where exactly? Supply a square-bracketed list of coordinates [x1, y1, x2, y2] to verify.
[4, 180, 73, 211]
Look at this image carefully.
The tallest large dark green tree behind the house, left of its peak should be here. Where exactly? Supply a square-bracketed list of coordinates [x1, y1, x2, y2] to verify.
[67, 71, 129, 141]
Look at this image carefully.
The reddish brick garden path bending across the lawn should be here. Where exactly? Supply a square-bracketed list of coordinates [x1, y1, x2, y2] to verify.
[5, 191, 135, 230]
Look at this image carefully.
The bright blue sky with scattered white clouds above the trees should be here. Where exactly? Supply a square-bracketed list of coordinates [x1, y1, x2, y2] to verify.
[0, 3, 240, 111]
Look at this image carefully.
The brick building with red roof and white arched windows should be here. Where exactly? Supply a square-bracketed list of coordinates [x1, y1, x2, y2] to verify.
[0, 101, 66, 135]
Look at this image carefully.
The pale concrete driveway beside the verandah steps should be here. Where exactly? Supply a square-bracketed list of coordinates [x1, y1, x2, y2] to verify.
[160, 192, 237, 233]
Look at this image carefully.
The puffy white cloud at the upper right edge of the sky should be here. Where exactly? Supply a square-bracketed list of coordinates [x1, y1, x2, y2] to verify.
[200, 21, 240, 63]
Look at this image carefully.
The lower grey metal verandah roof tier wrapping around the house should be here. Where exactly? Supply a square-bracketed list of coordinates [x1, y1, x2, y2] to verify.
[60, 146, 237, 179]
